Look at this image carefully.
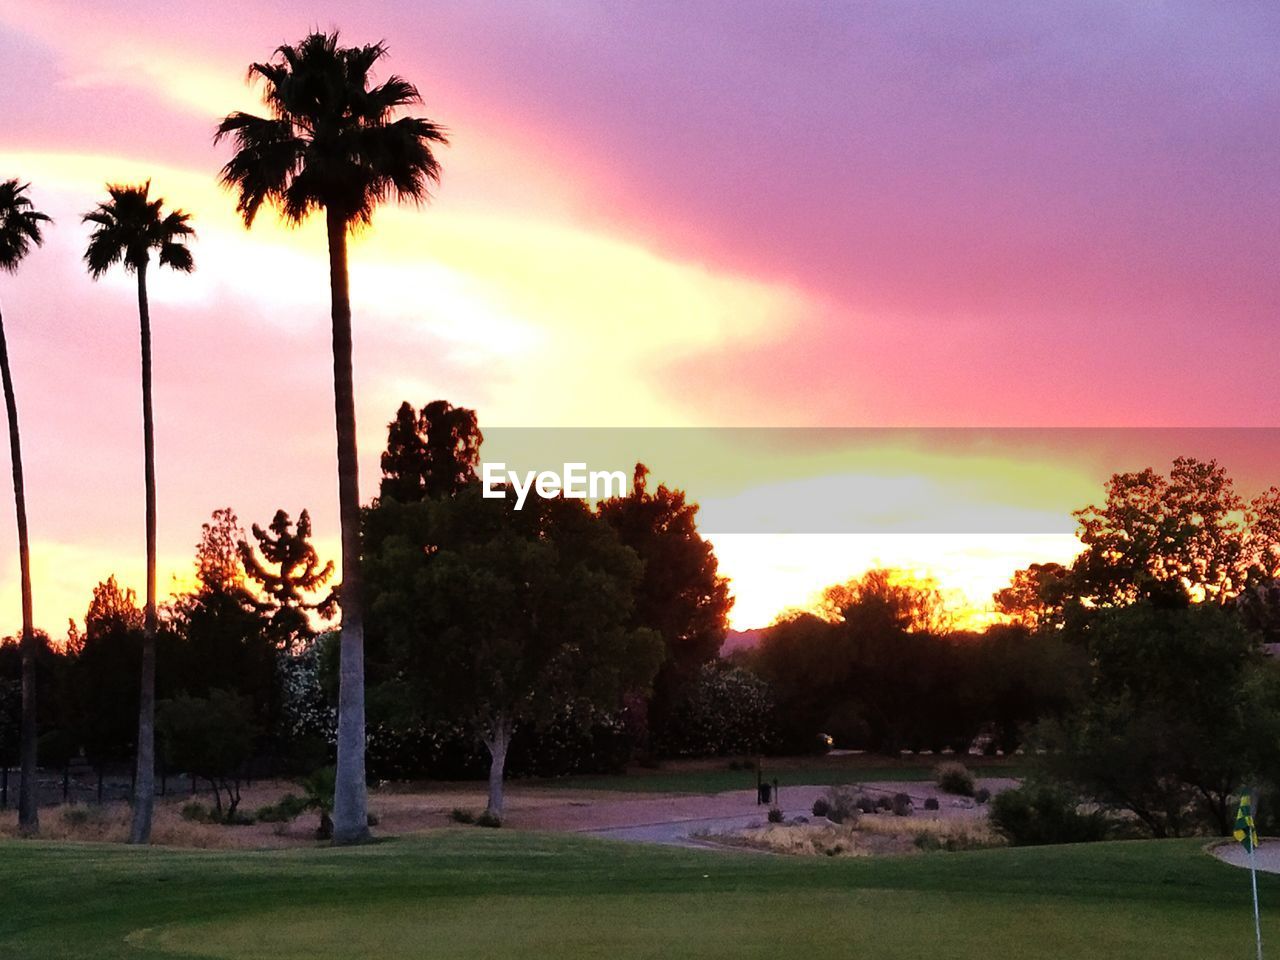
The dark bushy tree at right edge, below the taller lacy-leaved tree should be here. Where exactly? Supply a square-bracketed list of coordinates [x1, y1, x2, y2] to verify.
[1039, 602, 1280, 837]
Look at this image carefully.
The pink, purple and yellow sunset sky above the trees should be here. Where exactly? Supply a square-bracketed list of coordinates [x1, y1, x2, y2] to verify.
[0, 0, 1280, 637]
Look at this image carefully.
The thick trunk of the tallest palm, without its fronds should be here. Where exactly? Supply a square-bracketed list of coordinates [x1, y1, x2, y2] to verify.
[326, 210, 369, 844]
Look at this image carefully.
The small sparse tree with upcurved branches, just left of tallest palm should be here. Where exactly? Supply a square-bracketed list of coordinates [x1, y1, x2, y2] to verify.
[237, 509, 333, 652]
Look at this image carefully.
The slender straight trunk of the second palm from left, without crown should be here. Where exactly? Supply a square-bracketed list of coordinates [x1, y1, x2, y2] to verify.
[129, 264, 156, 844]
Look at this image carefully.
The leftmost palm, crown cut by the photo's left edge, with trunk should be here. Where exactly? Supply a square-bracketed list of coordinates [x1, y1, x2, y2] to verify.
[0, 180, 51, 833]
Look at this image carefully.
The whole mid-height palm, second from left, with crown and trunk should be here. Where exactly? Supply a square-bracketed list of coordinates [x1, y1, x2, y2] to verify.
[84, 180, 196, 844]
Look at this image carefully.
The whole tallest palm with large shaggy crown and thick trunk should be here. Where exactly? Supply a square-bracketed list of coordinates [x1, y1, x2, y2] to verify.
[214, 33, 448, 844]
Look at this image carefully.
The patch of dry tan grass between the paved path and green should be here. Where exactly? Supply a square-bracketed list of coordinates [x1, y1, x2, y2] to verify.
[699, 815, 1004, 856]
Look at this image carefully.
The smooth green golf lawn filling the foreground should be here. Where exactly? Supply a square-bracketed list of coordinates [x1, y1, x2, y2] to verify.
[0, 829, 1280, 960]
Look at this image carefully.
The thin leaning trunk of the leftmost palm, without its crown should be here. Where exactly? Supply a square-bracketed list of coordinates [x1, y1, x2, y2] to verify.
[0, 302, 40, 833]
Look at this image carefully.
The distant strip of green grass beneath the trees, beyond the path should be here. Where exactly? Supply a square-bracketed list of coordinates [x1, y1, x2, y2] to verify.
[542, 754, 1027, 794]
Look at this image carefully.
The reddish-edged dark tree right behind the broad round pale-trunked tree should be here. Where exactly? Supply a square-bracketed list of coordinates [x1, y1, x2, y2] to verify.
[599, 463, 733, 746]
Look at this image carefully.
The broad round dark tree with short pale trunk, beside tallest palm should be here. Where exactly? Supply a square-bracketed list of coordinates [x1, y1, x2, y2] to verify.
[369, 486, 662, 818]
